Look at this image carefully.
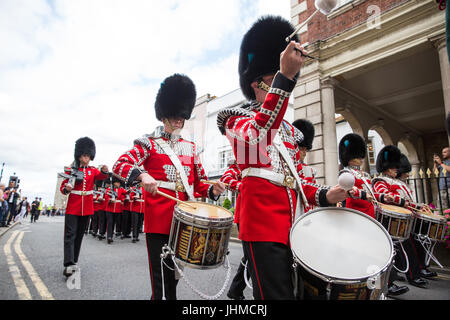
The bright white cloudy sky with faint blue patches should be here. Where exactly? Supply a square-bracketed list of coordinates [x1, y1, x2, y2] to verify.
[0, 0, 290, 204]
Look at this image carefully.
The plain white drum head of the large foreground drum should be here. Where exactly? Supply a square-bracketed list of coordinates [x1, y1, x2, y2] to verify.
[290, 208, 393, 280]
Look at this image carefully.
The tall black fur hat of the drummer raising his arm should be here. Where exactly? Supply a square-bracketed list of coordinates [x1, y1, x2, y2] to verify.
[239, 15, 298, 100]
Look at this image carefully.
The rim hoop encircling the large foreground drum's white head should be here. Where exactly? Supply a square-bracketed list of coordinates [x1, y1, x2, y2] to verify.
[289, 207, 394, 284]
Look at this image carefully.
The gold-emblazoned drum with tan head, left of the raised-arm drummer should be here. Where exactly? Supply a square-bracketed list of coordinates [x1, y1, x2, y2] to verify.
[169, 201, 234, 269]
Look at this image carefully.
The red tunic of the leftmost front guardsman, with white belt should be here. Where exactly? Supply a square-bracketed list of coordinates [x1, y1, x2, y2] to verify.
[60, 166, 108, 216]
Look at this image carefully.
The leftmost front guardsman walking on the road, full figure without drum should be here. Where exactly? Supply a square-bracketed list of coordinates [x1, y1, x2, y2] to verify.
[60, 137, 108, 277]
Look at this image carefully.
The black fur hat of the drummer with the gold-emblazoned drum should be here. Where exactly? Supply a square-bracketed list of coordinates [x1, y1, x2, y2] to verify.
[155, 73, 197, 121]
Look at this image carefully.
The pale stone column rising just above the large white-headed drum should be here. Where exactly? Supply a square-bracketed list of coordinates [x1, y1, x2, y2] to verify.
[321, 78, 339, 186]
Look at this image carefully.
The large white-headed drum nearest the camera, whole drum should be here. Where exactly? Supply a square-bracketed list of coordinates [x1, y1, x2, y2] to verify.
[290, 207, 394, 300]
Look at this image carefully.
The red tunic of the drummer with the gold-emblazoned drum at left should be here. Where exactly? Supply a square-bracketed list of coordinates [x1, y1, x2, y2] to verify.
[113, 133, 212, 235]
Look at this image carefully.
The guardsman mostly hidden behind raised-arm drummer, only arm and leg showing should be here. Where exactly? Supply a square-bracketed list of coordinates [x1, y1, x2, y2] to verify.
[220, 160, 249, 300]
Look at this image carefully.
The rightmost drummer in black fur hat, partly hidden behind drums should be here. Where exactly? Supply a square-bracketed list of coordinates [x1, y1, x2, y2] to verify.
[396, 154, 437, 282]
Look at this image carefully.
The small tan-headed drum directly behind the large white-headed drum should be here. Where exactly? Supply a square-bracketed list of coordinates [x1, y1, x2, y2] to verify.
[376, 203, 414, 241]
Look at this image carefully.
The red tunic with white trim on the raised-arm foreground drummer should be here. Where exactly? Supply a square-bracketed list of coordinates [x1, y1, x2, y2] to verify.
[217, 73, 327, 244]
